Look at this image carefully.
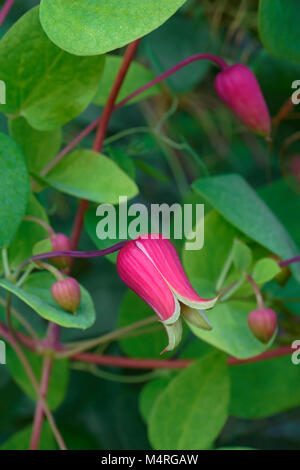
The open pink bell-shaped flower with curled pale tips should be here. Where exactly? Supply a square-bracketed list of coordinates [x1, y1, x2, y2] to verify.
[117, 234, 217, 352]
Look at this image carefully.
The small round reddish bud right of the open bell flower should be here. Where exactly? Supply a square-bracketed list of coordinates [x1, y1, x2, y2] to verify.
[248, 308, 277, 343]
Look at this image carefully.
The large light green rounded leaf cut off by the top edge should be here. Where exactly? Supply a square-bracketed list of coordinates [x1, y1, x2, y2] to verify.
[40, 0, 185, 55]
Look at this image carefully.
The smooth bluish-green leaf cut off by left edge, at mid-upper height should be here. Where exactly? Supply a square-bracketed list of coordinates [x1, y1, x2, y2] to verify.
[0, 133, 29, 248]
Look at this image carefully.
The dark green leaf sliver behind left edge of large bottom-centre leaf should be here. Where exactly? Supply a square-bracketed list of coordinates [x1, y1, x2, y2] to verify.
[139, 374, 174, 423]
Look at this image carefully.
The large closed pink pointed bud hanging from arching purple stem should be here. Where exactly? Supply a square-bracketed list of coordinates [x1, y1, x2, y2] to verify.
[215, 64, 271, 136]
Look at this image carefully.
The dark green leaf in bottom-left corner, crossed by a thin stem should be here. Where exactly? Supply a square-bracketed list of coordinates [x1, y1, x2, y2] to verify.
[0, 421, 57, 451]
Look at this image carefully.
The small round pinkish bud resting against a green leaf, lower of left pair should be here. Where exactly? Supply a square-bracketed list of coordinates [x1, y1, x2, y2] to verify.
[51, 277, 80, 313]
